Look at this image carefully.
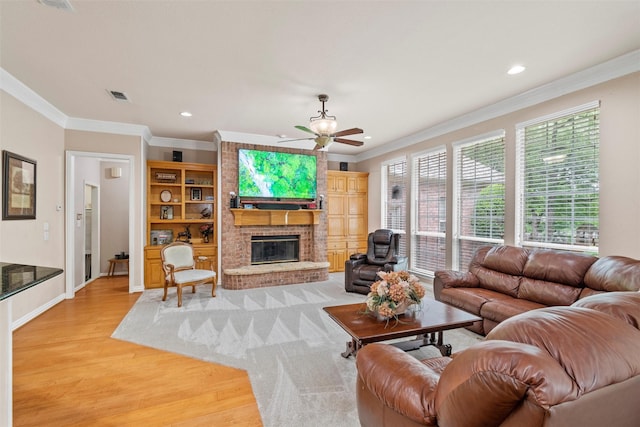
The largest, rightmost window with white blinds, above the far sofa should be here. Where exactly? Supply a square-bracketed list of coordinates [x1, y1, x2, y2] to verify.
[517, 103, 600, 254]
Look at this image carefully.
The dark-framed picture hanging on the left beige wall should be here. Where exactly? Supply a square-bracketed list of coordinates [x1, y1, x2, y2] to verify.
[2, 150, 36, 220]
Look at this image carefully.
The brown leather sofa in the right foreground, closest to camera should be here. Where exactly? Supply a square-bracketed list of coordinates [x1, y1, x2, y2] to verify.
[356, 292, 640, 427]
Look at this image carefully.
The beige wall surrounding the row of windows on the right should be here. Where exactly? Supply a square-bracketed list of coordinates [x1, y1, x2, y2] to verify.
[357, 73, 640, 265]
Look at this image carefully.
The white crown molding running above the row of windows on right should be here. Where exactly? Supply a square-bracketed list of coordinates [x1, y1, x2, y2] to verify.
[355, 50, 640, 162]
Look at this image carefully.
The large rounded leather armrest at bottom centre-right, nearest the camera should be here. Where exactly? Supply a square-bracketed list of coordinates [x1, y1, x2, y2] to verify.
[435, 339, 576, 426]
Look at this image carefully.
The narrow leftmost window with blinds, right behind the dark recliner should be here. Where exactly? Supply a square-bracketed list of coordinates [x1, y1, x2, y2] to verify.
[382, 159, 407, 256]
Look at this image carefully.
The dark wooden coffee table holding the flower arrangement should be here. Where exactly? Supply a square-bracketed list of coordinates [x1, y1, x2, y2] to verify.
[323, 298, 482, 358]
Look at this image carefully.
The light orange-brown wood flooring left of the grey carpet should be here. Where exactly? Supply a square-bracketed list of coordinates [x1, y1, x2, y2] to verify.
[13, 276, 262, 426]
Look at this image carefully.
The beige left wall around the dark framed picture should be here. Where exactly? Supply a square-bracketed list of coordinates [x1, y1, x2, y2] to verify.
[0, 91, 65, 322]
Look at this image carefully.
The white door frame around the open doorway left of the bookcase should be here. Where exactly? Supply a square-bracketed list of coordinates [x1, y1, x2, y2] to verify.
[65, 150, 136, 299]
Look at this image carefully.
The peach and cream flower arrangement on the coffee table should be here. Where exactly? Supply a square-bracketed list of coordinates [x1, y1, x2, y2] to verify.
[366, 270, 425, 320]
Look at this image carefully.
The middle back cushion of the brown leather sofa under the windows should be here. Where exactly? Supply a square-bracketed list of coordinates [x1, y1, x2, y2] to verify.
[523, 250, 598, 287]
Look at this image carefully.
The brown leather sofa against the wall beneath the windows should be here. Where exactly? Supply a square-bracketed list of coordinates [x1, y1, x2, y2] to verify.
[433, 246, 640, 336]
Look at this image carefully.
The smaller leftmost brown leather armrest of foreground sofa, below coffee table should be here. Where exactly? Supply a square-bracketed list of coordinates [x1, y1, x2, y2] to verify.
[356, 344, 450, 425]
